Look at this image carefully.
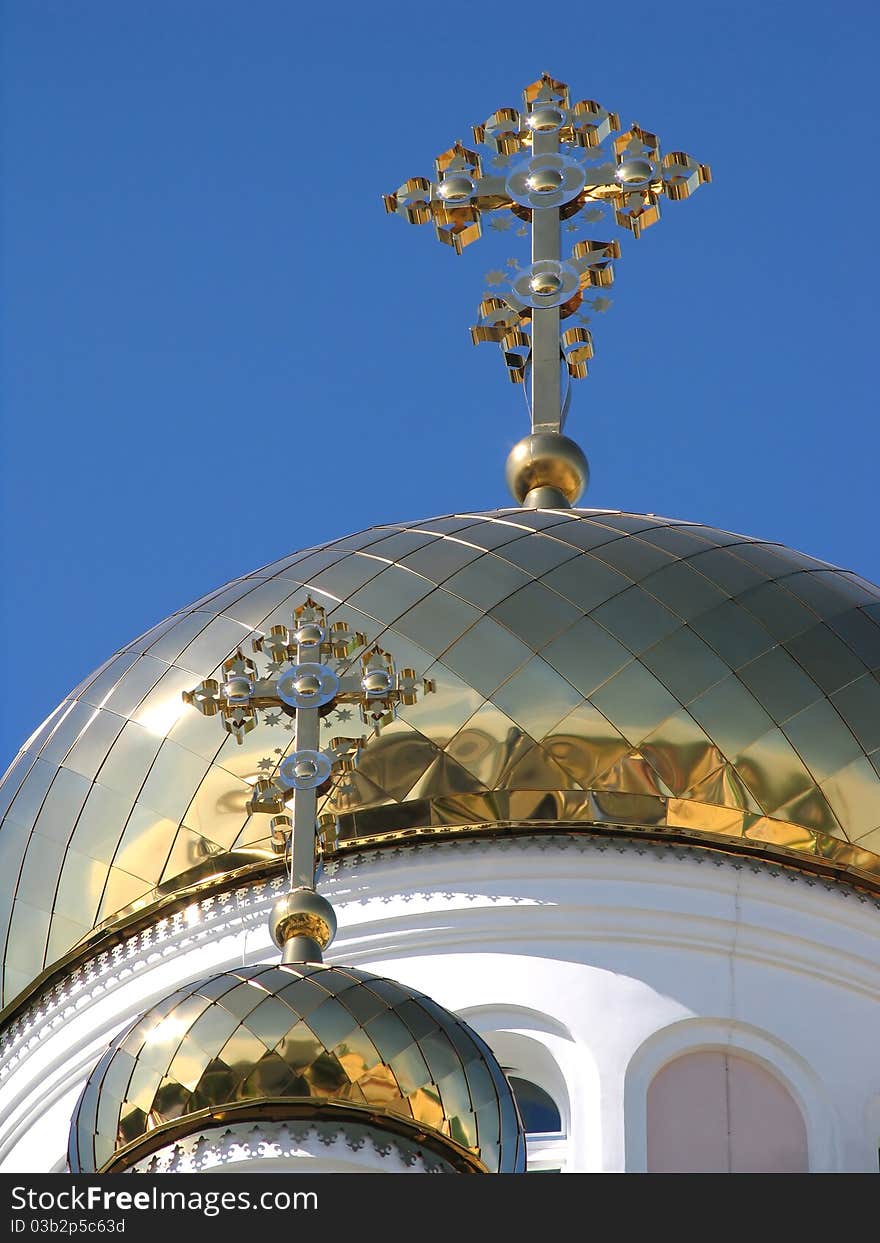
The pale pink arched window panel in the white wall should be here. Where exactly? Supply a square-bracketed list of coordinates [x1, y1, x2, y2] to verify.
[648, 1049, 808, 1173]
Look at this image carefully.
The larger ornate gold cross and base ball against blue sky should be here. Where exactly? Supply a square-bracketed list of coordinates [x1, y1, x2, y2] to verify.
[384, 73, 711, 505]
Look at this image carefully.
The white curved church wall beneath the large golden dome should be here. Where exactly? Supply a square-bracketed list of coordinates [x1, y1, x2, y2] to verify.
[0, 835, 880, 1171]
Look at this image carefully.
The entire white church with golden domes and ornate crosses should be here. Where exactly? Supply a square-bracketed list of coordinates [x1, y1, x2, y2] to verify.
[0, 75, 880, 1173]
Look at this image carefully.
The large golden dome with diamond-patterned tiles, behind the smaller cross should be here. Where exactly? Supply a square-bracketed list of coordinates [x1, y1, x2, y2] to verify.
[0, 510, 880, 1002]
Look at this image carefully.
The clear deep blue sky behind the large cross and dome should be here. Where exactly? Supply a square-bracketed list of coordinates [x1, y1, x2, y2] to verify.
[0, 0, 880, 761]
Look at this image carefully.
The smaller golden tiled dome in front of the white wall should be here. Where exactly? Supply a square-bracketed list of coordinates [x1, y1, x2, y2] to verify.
[70, 965, 526, 1173]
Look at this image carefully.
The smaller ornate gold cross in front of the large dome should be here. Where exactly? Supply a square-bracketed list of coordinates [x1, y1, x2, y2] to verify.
[183, 597, 434, 889]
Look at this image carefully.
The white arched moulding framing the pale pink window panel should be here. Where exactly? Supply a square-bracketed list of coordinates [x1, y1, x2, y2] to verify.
[624, 1018, 840, 1173]
